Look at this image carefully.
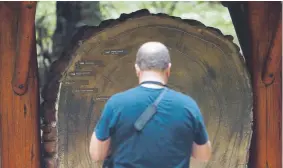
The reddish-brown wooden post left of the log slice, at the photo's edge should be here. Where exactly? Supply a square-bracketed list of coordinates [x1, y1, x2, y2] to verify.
[0, 2, 40, 168]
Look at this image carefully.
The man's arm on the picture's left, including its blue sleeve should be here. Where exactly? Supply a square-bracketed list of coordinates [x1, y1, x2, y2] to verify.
[89, 101, 116, 162]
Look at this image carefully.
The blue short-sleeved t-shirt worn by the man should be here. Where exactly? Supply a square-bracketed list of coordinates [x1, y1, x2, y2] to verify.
[95, 86, 208, 168]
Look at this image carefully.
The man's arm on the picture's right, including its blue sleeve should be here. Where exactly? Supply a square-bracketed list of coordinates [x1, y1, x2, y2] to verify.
[192, 109, 211, 162]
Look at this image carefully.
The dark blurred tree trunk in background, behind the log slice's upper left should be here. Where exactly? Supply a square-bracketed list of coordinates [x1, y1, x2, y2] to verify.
[52, 1, 101, 61]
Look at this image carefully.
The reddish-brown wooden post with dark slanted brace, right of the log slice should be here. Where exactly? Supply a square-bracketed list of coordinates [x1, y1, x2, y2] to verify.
[225, 1, 282, 168]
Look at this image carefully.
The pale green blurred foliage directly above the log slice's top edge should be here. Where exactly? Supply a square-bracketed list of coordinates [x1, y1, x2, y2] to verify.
[100, 1, 239, 45]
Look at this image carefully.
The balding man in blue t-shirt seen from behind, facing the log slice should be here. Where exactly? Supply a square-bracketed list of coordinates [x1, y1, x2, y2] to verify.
[90, 42, 211, 168]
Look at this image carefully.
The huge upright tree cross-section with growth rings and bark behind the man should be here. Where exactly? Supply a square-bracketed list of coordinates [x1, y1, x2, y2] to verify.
[42, 10, 252, 168]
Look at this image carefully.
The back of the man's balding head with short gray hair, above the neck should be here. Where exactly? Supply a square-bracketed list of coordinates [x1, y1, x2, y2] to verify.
[136, 42, 171, 71]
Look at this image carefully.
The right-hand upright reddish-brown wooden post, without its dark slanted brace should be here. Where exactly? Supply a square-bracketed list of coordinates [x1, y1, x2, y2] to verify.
[246, 1, 282, 168]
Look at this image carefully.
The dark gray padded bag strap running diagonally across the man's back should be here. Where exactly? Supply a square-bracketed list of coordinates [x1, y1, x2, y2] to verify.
[134, 87, 168, 131]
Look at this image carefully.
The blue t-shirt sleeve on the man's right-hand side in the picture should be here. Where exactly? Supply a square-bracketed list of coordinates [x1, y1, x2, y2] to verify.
[194, 109, 208, 145]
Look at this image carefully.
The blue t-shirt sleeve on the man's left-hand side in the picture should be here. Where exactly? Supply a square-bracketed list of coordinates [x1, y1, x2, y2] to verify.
[95, 101, 117, 141]
